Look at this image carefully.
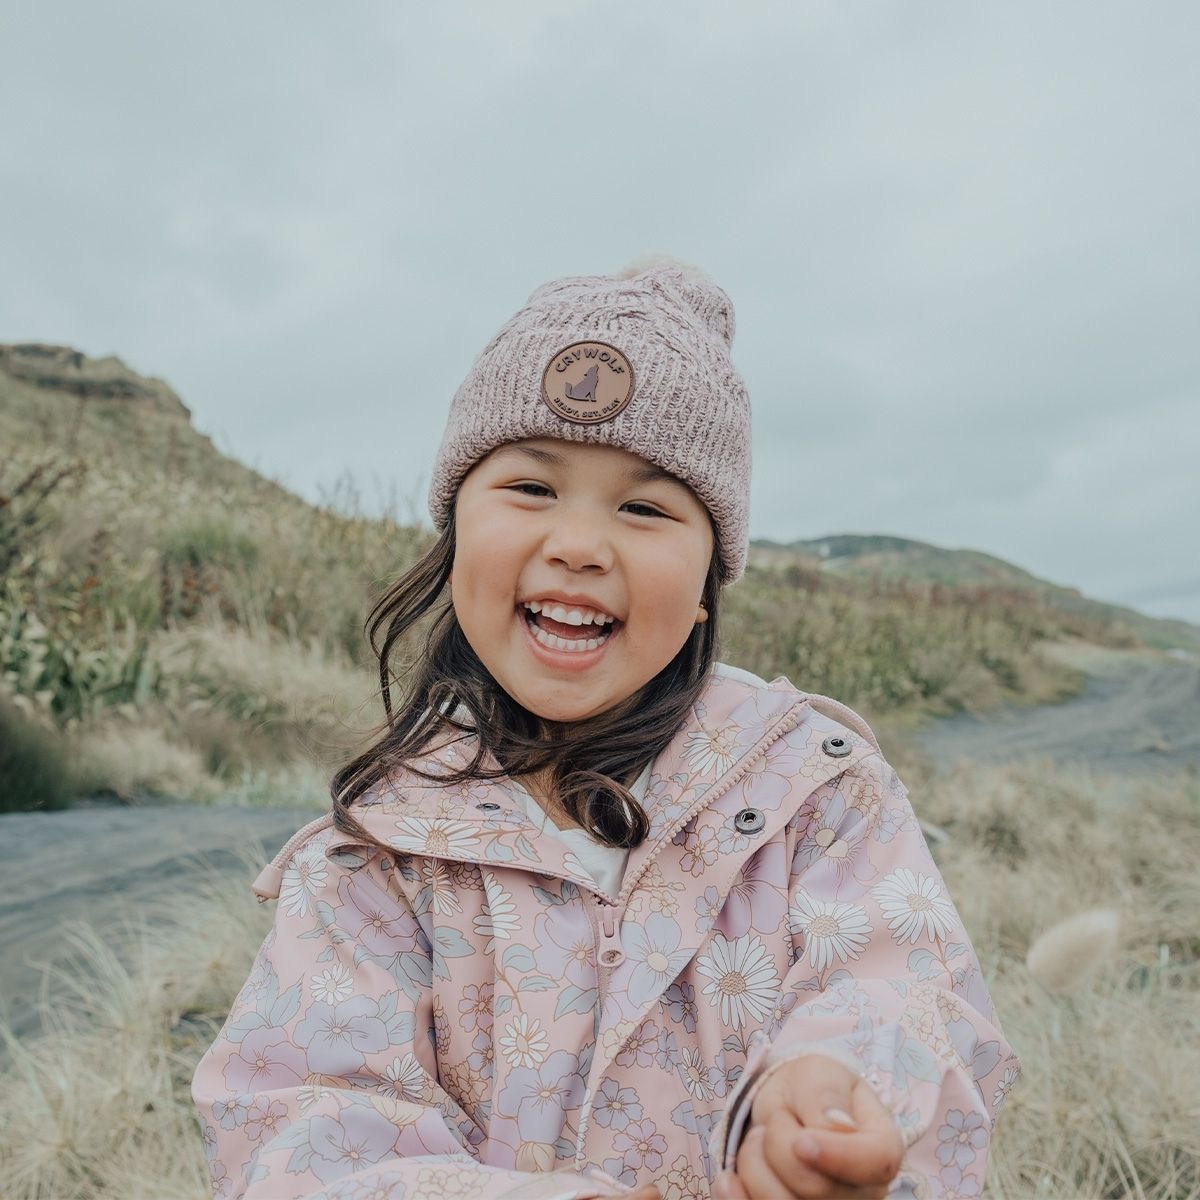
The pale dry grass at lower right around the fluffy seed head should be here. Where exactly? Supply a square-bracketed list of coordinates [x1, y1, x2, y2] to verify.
[913, 761, 1200, 1200]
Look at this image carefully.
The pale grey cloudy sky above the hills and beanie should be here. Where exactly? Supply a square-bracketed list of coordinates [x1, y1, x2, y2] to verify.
[0, 9, 1200, 622]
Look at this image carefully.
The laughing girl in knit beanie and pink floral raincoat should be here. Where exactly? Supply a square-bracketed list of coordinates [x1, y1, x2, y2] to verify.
[193, 260, 1019, 1200]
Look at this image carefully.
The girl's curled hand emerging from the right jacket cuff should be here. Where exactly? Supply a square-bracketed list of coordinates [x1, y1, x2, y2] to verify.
[713, 1055, 904, 1200]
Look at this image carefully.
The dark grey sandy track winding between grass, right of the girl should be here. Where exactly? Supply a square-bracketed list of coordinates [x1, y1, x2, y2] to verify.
[914, 643, 1200, 773]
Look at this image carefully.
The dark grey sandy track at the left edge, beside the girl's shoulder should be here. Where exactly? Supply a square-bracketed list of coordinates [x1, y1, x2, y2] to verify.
[0, 805, 319, 1034]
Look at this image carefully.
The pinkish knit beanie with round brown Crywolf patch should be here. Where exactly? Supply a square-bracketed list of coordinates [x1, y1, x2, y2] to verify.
[428, 257, 750, 584]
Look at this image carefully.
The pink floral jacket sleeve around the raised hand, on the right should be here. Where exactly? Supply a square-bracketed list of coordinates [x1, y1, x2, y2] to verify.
[710, 754, 1020, 1196]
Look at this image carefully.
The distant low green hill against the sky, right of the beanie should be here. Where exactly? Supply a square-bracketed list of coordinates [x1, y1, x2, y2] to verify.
[750, 534, 1200, 653]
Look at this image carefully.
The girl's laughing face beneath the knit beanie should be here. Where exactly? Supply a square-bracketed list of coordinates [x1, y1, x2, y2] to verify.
[450, 438, 713, 722]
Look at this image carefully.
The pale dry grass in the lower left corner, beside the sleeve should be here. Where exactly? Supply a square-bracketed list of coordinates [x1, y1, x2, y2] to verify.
[0, 852, 271, 1200]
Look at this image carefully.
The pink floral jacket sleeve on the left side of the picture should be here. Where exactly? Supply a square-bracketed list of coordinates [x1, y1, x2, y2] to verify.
[192, 834, 626, 1200]
